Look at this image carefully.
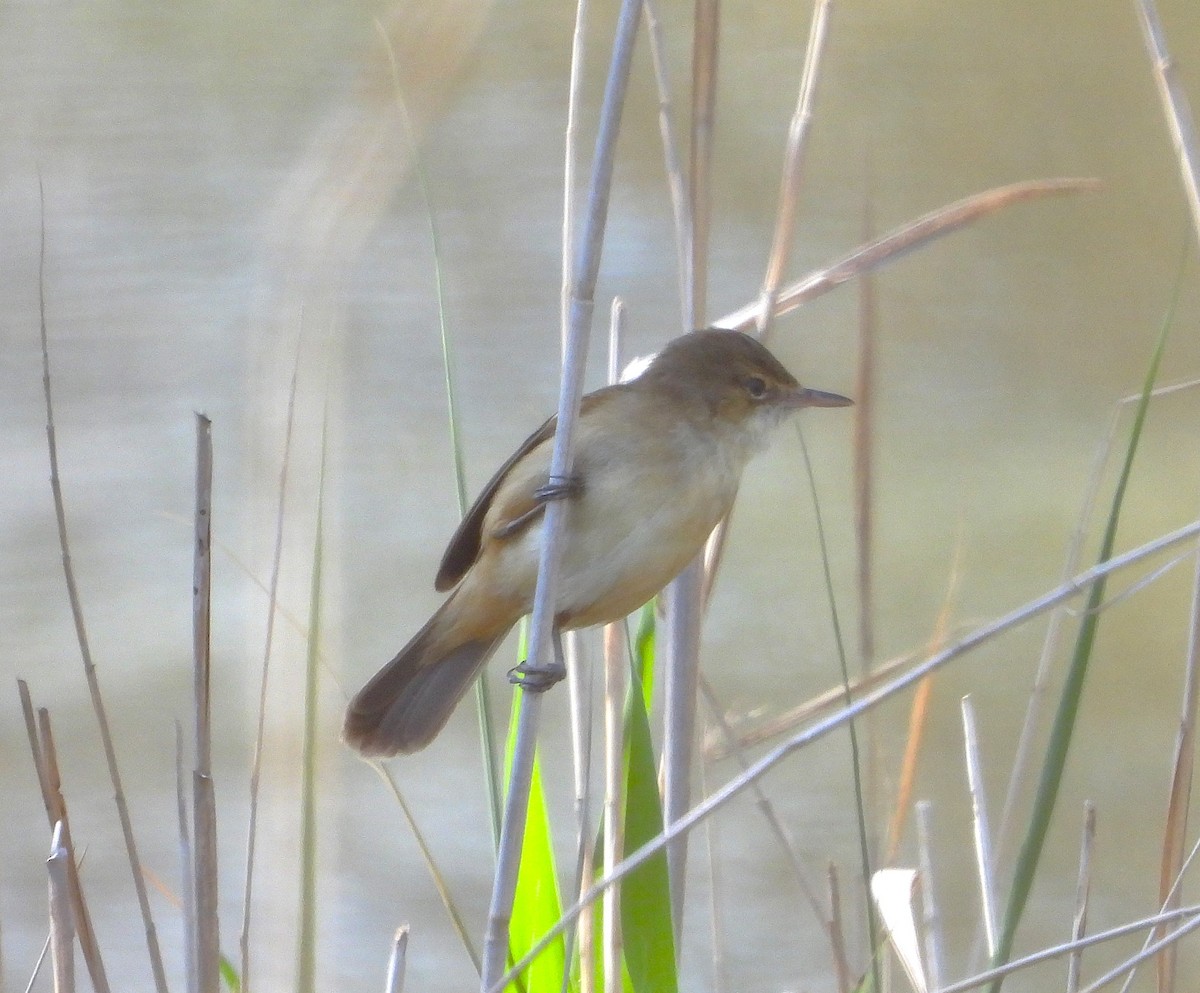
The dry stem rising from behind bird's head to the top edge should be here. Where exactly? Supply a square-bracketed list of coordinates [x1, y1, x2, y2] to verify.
[757, 0, 830, 338]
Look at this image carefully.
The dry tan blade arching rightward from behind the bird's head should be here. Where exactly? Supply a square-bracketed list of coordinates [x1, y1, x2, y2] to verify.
[713, 179, 1100, 331]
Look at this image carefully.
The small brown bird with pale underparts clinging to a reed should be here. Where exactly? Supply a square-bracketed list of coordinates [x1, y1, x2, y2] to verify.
[343, 330, 851, 756]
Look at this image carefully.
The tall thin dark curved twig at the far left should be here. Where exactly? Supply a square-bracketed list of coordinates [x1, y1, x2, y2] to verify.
[37, 176, 167, 993]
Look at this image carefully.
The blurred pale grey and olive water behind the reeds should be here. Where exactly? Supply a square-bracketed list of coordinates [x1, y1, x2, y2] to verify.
[0, 0, 1200, 992]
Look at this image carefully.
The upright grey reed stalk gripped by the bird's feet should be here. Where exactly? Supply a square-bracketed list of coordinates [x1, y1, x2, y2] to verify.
[482, 0, 641, 989]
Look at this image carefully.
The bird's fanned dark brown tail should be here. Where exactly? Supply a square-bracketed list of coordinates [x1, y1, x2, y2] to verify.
[342, 596, 511, 757]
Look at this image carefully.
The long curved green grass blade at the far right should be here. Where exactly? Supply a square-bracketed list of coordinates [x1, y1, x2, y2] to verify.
[990, 251, 1187, 993]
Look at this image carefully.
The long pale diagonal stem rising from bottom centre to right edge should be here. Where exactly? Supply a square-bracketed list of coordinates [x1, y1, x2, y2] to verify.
[485, 520, 1200, 993]
